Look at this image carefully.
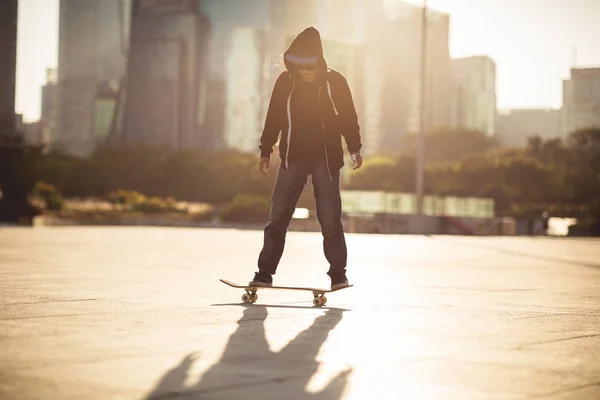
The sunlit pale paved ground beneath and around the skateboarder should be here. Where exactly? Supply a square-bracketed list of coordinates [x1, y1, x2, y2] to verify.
[0, 228, 600, 400]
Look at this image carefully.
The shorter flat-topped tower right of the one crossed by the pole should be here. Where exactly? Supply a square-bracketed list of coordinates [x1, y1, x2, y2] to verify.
[450, 56, 496, 136]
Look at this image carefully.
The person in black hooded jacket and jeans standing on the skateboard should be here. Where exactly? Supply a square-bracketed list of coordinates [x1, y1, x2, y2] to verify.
[250, 27, 362, 289]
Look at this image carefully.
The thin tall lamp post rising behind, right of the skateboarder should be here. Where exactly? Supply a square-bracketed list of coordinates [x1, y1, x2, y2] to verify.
[416, 0, 427, 220]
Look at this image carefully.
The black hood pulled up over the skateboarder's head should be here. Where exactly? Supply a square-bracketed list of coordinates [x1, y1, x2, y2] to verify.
[283, 26, 327, 77]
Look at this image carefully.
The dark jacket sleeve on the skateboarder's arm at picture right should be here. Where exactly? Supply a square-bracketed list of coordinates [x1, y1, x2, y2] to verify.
[335, 73, 362, 153]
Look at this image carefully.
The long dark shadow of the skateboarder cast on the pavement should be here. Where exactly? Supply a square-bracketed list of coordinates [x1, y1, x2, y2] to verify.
[146, 305, 352, 400]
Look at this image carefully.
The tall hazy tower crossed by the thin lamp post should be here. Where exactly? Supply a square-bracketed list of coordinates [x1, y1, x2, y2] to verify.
[360, 2, 451, 154]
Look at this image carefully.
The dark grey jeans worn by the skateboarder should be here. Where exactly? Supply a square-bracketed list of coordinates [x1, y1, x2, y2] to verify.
[258, 162, 347, 276]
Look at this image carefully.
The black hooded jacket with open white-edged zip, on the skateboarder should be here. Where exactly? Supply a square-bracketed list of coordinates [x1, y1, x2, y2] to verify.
[259, 27, 362, 177]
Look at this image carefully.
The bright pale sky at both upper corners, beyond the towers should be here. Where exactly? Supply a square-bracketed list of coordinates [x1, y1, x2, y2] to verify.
[16, 0, 600, 121]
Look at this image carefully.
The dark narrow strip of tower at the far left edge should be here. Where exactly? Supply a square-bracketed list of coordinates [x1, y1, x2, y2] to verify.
[0, 0, 19, 137]
